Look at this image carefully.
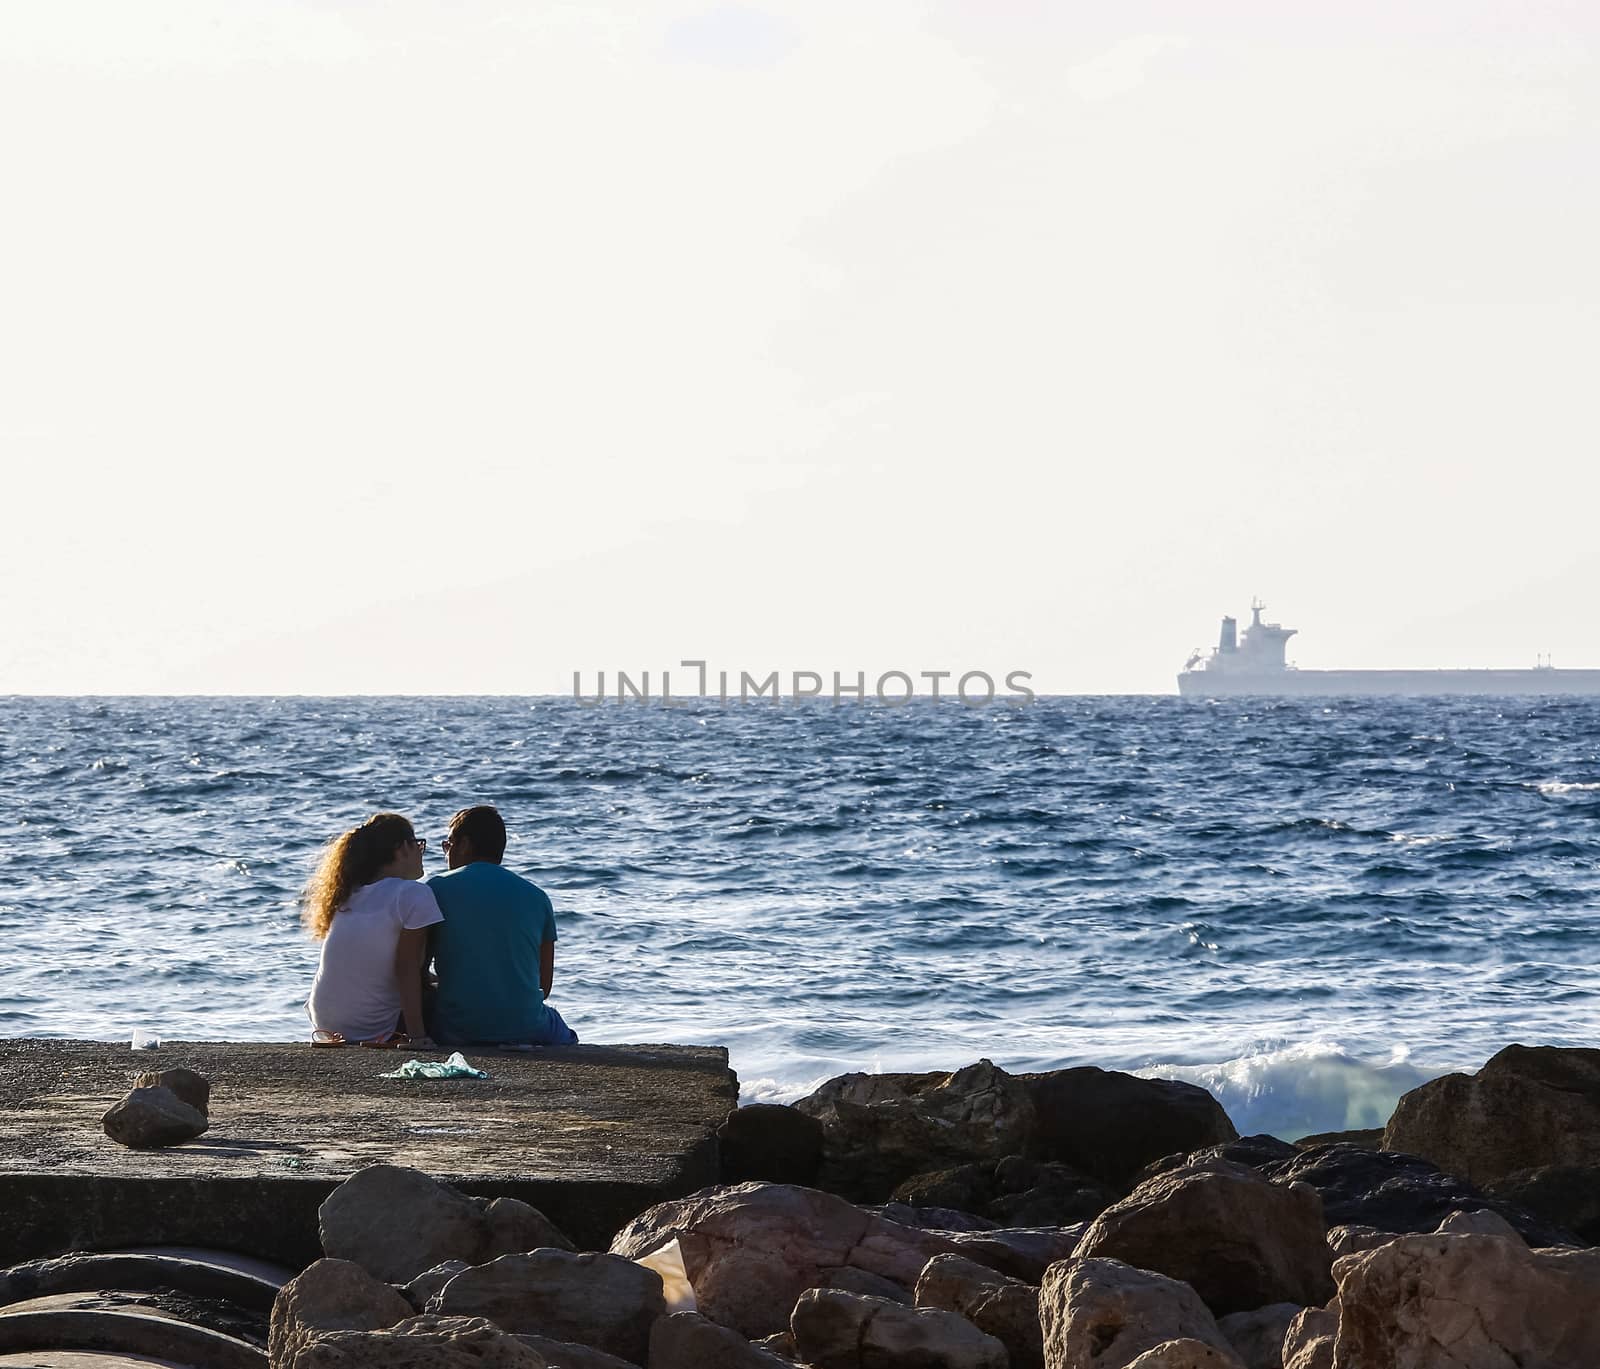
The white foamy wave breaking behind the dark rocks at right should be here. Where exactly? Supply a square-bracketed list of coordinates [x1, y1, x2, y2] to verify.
[1134, 1041, 1442, 1140]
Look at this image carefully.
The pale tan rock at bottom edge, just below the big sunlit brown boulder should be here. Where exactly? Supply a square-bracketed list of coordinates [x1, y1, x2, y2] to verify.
[1038, 1259, 1229, 1369]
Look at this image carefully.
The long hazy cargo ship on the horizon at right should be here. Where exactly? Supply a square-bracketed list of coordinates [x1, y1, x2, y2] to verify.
[1178, 600, 1600, 699]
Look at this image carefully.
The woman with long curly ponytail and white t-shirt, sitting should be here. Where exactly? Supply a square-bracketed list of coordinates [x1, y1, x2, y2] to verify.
[302, 812, 445, 1049]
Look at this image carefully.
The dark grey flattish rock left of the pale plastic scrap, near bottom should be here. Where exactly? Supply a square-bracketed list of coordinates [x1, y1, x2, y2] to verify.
[427, 1249, 666, 1364]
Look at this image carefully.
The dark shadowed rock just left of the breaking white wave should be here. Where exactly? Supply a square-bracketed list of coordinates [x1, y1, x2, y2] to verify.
[1021, 1065, 1238, 1193]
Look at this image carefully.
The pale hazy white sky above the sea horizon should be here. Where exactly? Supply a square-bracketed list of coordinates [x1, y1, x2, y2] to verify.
[0, 0, 1600, 692]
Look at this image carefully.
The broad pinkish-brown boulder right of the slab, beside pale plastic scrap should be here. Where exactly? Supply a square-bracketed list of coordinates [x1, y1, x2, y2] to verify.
[611, 1183, 955, 1340]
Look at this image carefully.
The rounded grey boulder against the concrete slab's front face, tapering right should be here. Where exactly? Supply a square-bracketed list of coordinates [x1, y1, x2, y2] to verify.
[317, 1164, 571, 1284]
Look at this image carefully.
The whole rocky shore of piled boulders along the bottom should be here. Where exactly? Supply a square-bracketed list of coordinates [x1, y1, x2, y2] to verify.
[0, 1046, 1600, 1369]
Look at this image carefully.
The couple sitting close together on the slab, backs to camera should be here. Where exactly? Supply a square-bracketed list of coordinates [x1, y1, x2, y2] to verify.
[304, 804, 578, 1051]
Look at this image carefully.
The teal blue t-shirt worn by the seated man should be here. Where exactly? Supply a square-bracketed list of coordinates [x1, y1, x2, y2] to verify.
[427, 860, 555, 1044]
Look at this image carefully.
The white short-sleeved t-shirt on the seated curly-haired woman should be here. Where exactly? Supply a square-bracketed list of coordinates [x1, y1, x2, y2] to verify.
[306, 878, 445, 1041]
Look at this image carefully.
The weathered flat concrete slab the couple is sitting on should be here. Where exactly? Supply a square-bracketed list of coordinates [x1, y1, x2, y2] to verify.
[0, 1040, 738, 1268]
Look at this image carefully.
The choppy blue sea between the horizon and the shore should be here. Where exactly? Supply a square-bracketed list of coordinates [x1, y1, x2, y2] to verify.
[0, 697, 1600, 1139]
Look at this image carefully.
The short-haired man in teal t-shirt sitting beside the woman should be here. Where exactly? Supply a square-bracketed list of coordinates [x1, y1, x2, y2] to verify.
[427, 804, 578, 1046]
